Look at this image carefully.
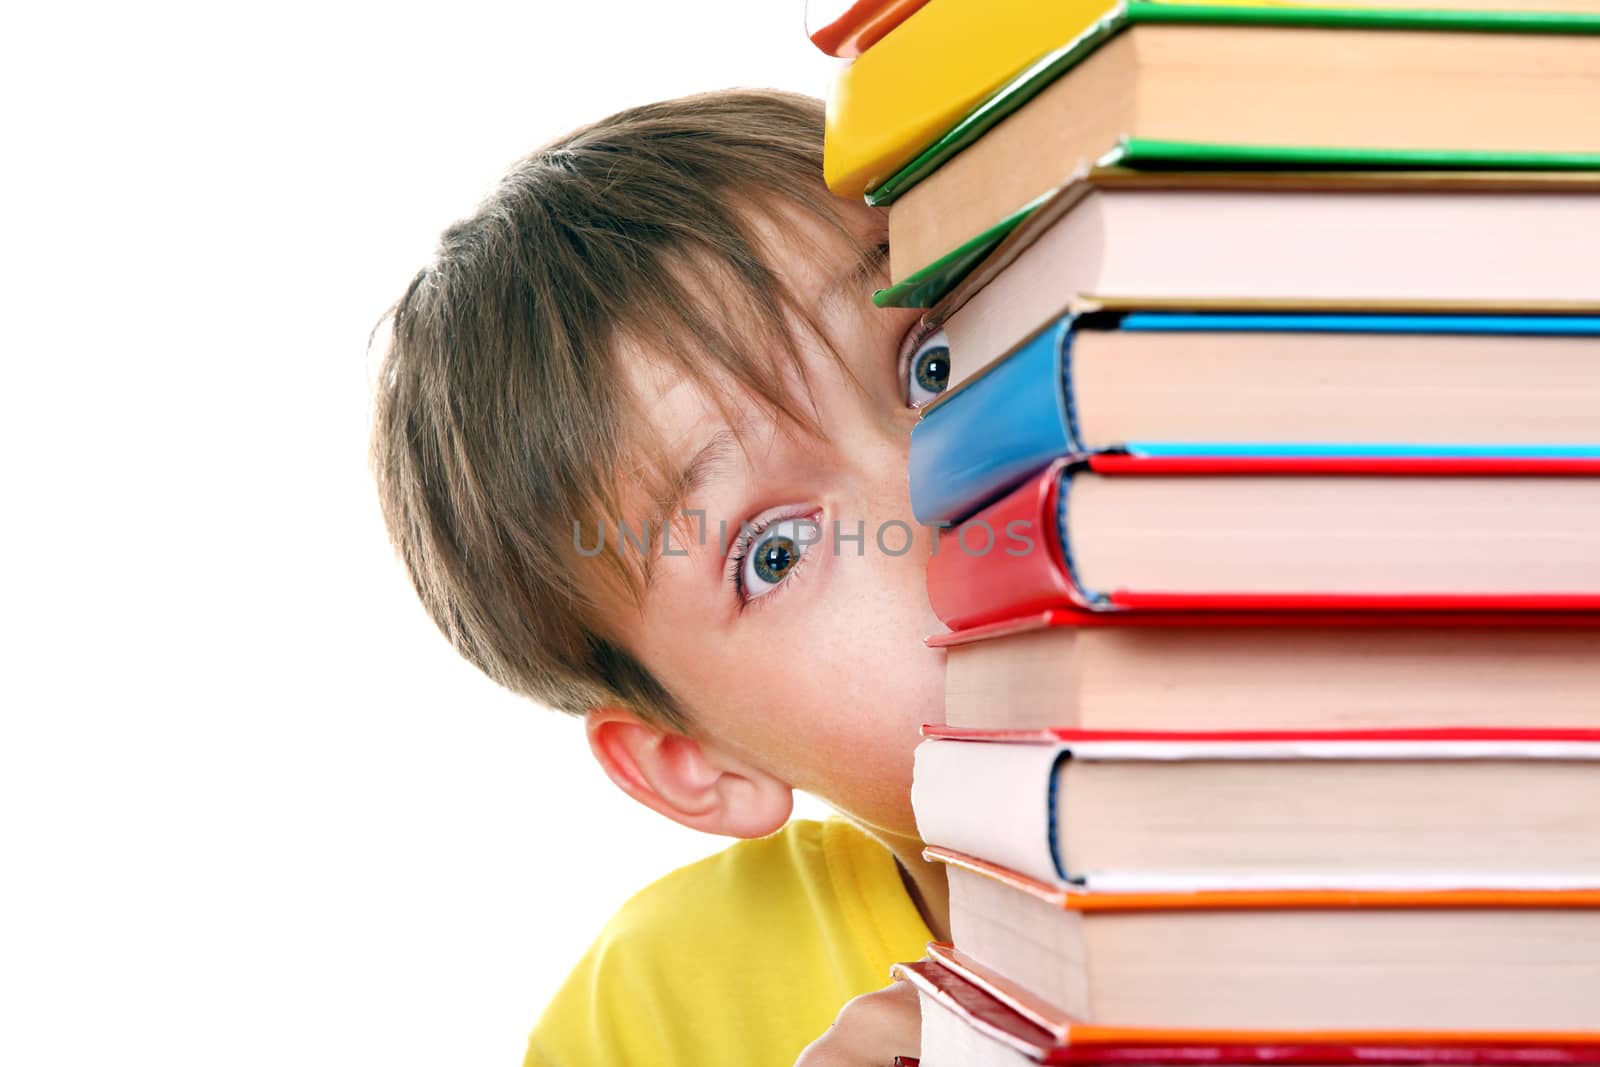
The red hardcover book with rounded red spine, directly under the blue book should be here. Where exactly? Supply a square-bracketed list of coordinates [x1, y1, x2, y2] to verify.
[928, 454, 1600, 630]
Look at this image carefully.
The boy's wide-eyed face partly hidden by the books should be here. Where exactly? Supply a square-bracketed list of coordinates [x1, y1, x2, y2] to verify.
[604, 195, 944, 838]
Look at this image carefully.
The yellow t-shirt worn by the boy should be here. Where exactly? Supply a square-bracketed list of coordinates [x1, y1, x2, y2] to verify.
[523, 819, 931, 1067]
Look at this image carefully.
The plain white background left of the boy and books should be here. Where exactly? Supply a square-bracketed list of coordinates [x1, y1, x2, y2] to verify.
[0, 0, 832, 1065]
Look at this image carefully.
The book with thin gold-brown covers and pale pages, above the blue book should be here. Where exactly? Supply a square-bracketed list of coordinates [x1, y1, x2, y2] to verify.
[874, 166, 1600, 308]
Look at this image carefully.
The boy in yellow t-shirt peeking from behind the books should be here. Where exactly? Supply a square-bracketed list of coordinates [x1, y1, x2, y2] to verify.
[373, 91, 947, 1067]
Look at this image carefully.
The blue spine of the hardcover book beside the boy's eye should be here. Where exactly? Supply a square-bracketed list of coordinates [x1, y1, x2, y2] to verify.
[909, 320, 1075, 526]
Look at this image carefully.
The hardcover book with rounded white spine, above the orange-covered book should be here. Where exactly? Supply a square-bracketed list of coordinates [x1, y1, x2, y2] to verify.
[912, 726, 1600, 891]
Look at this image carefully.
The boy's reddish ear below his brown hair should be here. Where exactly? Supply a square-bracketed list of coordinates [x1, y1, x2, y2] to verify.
[584, 707, 795, 837]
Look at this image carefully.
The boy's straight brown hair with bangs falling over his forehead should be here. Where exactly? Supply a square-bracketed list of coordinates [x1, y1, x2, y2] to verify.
[373, 90, 861, 723]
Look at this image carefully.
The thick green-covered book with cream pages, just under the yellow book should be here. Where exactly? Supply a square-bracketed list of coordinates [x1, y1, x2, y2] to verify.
[867, 0, 1600, 307]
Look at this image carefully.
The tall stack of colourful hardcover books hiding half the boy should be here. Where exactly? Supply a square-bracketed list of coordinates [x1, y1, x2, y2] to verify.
[813, 0, 1600, 1067]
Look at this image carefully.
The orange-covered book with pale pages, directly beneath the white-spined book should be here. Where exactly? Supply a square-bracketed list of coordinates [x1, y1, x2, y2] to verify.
[923, 844, 1600, 1040]
